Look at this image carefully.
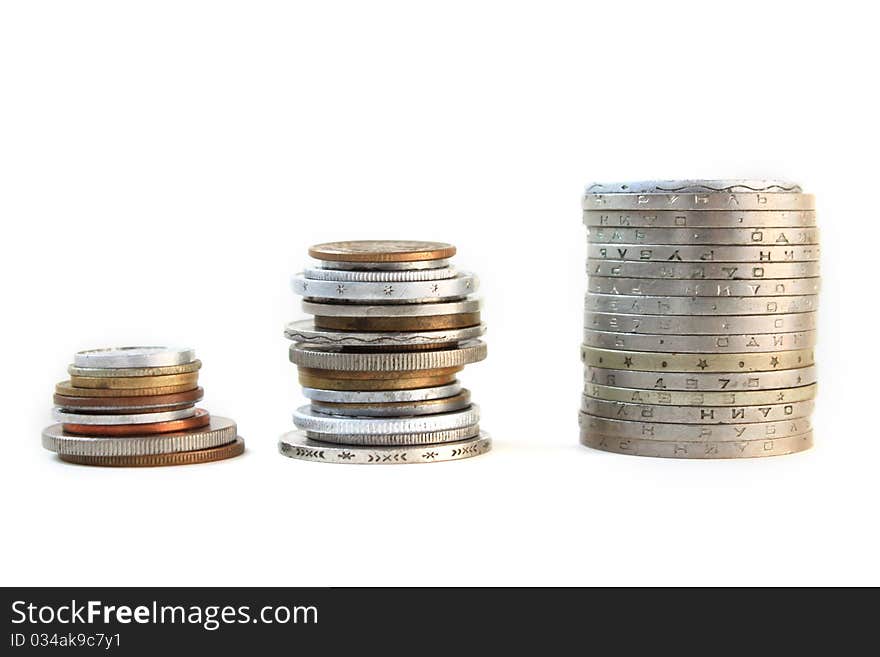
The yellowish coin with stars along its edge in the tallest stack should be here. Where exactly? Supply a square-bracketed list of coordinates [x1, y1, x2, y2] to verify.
[581, 346, 814, 372]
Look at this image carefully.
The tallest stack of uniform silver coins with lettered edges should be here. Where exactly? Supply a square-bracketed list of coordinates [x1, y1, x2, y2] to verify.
[580, 180, 819, 458]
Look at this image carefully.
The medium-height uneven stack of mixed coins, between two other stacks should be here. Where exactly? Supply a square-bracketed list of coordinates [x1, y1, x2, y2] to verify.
[279, 241, 491, 464]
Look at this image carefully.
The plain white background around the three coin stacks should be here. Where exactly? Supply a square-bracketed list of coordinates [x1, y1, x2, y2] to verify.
[0, 0, 880, 585]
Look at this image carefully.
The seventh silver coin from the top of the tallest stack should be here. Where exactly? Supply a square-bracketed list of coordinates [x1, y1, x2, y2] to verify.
[587, 276, 821, 297]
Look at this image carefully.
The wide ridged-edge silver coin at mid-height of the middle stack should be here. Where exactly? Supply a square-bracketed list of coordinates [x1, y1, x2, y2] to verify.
[290, 340, 486, 372]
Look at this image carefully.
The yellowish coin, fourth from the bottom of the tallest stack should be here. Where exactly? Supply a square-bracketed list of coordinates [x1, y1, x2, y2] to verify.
[584, 384, 816, 406]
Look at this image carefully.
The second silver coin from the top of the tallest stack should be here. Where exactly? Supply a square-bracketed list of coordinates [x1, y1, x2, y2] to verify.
[583, 192, 816, 210]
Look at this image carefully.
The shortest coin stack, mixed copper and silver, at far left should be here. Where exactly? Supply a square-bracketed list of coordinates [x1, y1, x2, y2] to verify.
[43, 347, 244, 466]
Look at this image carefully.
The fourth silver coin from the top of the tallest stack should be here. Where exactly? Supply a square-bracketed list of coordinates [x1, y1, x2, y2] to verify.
[587, 226, 819, 246]
